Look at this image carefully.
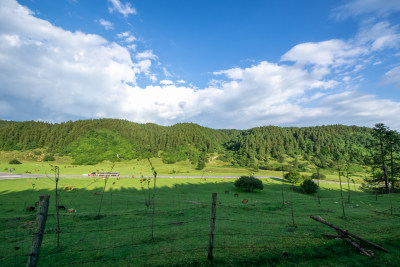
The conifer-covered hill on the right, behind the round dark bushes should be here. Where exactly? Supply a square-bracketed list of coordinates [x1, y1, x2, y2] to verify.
[225, 125, 373, 168]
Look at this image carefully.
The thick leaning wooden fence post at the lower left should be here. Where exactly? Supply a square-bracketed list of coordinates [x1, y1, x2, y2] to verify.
[26, 195, 50, 267]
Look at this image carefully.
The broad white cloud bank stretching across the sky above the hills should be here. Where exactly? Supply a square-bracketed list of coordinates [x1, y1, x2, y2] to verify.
[0, 0, 400, 129]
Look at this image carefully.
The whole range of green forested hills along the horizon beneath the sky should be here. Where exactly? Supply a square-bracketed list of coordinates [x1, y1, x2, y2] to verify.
[0, 119, 372, 166]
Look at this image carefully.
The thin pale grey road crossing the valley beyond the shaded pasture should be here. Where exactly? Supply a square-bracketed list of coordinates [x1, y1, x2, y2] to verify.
[0, 172, 361, 185]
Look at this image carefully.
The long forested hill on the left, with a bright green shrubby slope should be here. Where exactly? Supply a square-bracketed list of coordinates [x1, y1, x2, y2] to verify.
[0, 119, 231, 164]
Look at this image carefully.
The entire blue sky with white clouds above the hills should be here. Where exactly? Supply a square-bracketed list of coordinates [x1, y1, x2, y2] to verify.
[0, 0, 400, 130]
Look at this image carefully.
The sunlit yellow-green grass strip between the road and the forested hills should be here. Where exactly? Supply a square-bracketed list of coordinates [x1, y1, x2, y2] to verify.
[0, 151, 367, 183]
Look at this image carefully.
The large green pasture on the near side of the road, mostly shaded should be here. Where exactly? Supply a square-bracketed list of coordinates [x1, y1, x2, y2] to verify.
[0, 174, 400, 266]
